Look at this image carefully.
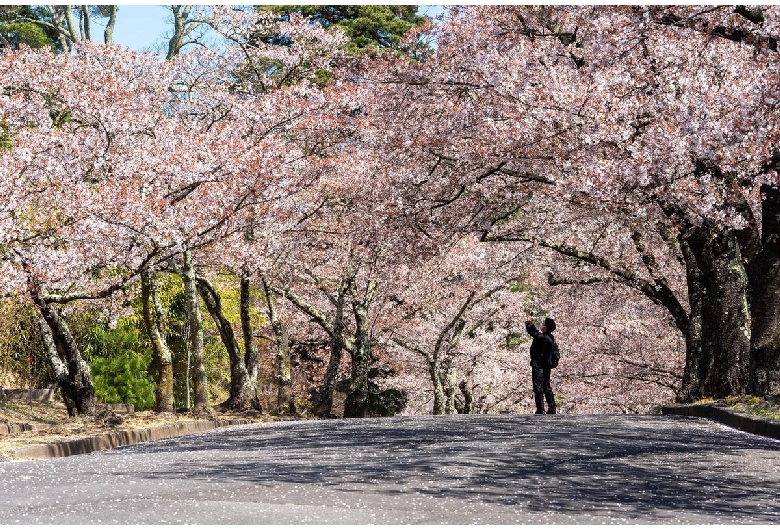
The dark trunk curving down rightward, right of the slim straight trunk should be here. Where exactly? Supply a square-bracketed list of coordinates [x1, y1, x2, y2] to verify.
[197, 277, 259, 410]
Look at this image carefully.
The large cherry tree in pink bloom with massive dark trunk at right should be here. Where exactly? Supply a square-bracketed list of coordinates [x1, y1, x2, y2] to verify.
[354, 7, 778, 400]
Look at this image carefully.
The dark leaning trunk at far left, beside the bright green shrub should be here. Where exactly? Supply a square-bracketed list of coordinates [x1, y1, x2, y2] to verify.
[30, 286, 95, 416]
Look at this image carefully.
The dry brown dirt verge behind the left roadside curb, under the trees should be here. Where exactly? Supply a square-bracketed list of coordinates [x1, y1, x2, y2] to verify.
[0, 400, 275, 461]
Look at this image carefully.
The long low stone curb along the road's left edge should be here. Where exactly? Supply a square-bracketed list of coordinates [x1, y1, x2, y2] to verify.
[14, 420, 255, 459]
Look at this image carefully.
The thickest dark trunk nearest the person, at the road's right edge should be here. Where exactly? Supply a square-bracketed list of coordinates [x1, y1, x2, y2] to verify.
[678, 227, 751, 401]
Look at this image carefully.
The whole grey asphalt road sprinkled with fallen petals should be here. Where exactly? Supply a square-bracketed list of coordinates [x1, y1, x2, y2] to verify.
[0, 415, 780, 525]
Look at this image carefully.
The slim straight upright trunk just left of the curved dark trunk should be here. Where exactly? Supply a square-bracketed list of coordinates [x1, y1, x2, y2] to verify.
[181, 250, 209, 412]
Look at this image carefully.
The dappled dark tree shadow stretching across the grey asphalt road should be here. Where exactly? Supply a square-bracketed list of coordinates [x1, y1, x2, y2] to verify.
[112, 416, 780, 522]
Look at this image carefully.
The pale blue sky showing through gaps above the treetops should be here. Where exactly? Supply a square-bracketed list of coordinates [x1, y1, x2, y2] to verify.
[108, 4, 443, 51]
